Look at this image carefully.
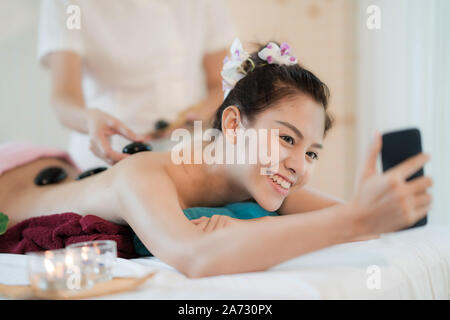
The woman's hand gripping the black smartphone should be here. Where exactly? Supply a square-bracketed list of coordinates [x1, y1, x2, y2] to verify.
[349, 132, 432, 235]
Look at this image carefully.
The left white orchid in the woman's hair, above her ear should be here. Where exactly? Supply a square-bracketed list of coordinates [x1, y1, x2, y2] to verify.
[220, 38, 250, 99]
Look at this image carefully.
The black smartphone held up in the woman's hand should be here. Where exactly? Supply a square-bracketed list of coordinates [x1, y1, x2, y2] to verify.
[381, 128, 427, 230]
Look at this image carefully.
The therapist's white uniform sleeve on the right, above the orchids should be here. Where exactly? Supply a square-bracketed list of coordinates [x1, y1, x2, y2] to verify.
[205, 0, 237, 53]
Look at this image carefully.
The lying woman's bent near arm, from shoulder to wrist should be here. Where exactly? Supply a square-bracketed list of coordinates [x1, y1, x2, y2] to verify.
[115, 155, 356, 277]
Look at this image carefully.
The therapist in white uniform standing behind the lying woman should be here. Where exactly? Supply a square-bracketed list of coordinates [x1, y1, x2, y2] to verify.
[38, 0, 235, 170]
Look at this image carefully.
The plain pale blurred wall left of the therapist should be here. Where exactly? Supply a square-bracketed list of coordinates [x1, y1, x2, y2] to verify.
[0, 0, 68, 148]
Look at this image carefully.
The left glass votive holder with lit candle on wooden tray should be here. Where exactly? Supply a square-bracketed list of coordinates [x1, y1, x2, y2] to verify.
[27, 249, 93, 294]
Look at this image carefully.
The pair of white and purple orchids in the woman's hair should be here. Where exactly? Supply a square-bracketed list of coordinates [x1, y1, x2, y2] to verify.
[221, 38, 298, 99]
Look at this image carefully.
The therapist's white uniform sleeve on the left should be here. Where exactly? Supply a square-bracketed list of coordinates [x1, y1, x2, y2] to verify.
[37, 0, 85, 67]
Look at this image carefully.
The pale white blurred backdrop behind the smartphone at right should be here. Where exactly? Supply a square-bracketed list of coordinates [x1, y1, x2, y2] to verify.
[355, 0, 450, 224]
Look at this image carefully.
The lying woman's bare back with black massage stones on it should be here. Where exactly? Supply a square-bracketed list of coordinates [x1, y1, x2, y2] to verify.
[0, 152, 192, 227]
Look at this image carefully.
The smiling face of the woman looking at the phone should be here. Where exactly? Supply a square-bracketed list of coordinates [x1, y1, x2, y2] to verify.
[227, 94, 325, 211]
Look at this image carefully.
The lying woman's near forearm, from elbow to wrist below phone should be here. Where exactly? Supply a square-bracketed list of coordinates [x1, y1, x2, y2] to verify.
[193, 204, 358, 277]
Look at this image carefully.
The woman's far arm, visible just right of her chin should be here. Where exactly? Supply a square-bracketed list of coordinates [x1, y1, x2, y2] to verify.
[277, 186, 345, 215]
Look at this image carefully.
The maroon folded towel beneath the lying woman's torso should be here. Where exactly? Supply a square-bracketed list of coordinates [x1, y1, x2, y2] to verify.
[0, 212, 138, 259]
